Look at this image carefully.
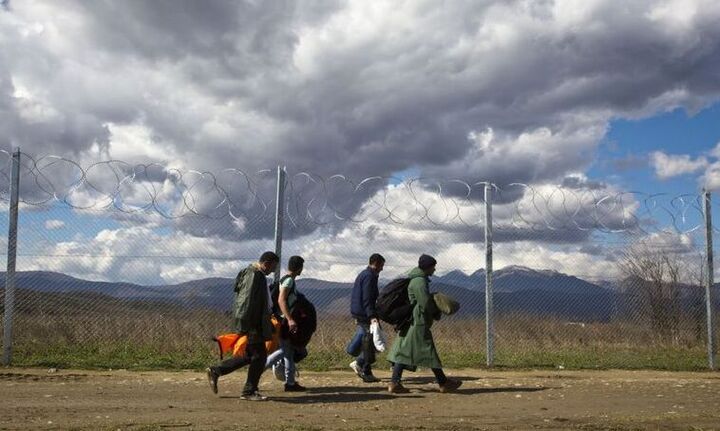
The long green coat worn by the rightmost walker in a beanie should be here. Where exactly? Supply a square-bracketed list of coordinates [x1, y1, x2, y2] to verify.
[388, 268, 442, 368]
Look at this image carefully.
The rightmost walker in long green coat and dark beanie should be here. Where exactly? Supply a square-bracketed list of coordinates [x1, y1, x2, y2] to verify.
[388, 254, 462, 394]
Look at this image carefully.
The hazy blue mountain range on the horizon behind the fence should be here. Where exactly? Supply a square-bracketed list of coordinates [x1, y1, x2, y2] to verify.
[0, 266, 717, 321]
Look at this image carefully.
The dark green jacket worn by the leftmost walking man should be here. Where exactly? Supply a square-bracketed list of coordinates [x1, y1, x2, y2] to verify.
[233, 265, 272, 343]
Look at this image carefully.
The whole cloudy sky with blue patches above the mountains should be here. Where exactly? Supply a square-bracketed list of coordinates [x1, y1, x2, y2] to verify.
[0, 0, 720, 284]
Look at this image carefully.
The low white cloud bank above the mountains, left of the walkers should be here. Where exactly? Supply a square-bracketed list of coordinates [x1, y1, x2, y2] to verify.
[20, 226, 267, 285]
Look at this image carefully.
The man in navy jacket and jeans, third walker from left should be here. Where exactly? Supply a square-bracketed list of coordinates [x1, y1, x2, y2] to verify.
[348, 253, 385, 383]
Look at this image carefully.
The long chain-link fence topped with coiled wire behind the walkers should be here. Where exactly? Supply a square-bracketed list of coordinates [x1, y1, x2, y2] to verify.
[0, 149, 720, 369]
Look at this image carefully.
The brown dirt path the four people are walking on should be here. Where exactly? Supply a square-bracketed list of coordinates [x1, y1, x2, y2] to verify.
[0, 368, 720, 430]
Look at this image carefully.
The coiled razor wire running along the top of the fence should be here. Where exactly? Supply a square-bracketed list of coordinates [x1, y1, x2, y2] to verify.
[0, 150, 720, 234]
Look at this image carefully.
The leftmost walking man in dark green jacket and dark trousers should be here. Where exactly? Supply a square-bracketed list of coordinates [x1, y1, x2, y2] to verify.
[205, 251, 280, 401]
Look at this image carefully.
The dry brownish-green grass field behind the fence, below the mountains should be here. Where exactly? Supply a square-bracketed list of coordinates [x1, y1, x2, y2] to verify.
[5, 310, 707, 371]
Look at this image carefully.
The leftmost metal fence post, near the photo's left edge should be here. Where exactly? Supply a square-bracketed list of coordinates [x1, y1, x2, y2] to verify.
[3, 148, 20, 365]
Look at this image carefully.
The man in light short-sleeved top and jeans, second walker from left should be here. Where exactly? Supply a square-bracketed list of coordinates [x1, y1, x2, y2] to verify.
[266, 256, 307, 392]
